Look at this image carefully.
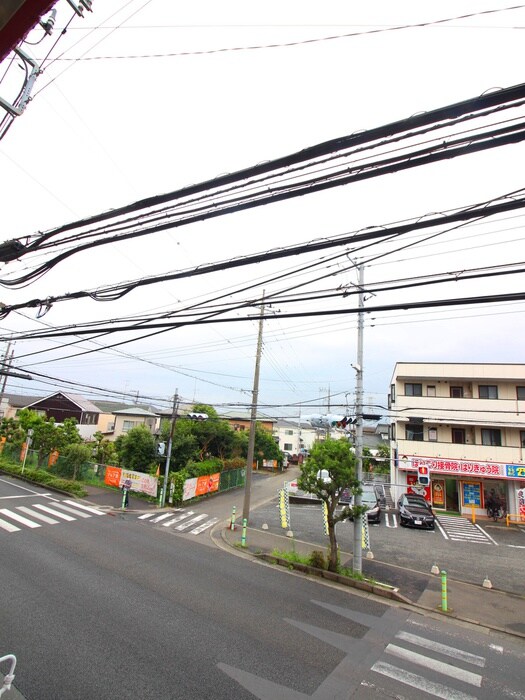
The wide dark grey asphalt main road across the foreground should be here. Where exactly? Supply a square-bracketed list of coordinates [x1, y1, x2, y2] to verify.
[0, 477, 525, 700]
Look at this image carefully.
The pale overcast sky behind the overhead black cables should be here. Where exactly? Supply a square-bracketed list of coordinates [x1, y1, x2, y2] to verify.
[0, 0, 525, 418]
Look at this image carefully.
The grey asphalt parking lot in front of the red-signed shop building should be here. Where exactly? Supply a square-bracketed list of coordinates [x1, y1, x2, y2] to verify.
[250, 499, 525, 595]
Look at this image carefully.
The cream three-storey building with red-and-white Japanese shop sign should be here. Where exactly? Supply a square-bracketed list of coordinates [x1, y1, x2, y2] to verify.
[389, 362, 525, 520]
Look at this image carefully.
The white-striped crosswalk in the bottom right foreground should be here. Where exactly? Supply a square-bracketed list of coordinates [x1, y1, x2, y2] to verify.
[371, 630, 486, 700]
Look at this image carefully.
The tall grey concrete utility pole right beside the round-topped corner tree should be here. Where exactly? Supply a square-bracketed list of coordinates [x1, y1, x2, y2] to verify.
[352, 265, 366, 574]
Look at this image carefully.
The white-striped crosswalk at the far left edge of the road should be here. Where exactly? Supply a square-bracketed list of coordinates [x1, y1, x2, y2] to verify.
[0, 500, 105, 533]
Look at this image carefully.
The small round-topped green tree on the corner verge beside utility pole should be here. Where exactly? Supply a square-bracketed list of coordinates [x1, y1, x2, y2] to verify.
[297, 438, 361, 571]
